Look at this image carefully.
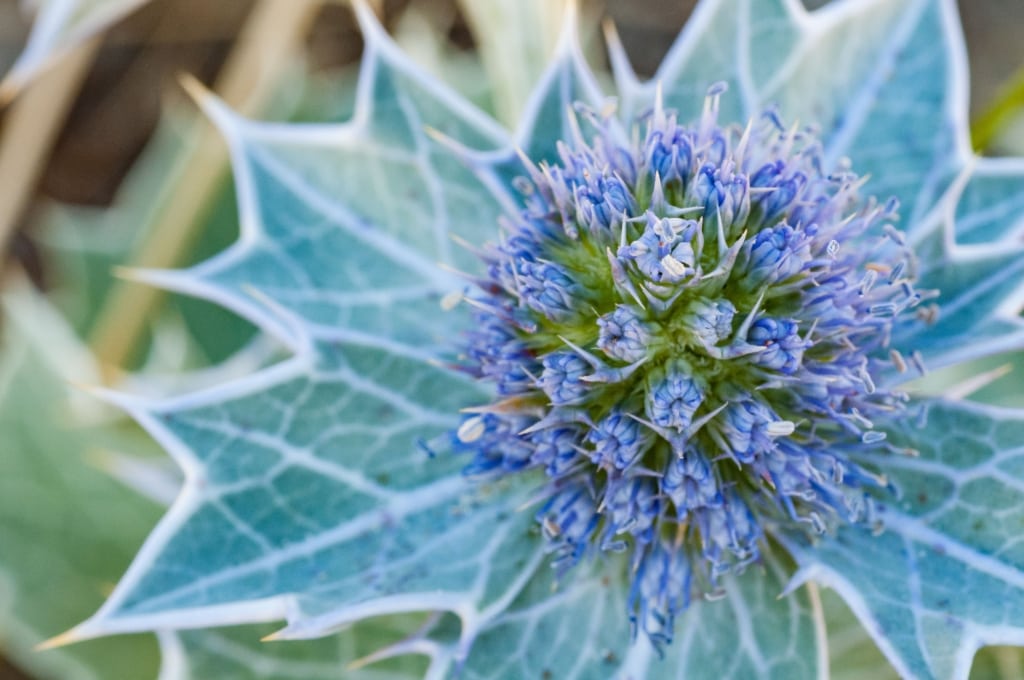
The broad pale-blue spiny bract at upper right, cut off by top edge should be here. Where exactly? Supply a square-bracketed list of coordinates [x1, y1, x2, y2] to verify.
[618, 0, 969, 224]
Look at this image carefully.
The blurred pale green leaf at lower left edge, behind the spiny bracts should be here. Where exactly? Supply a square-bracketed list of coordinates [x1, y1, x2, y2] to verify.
[0, 293, 160, 680]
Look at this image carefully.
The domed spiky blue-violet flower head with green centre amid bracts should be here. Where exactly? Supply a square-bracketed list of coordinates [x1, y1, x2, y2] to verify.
[458, 86, 923, 641]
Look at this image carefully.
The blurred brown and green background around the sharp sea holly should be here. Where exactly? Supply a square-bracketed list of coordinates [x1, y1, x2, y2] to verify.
[0, 0, 1024, 680]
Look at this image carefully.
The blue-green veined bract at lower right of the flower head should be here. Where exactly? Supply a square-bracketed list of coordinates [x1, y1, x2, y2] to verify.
[793, 401, 1024, 678]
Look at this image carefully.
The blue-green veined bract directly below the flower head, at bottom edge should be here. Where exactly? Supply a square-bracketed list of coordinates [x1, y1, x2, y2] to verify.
[448, 560, 827, 680]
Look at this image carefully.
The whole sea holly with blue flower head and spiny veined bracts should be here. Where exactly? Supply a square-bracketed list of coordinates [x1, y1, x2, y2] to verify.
[48, 0, 1024, 678]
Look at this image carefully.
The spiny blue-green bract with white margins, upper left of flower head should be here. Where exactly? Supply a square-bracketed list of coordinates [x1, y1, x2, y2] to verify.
[139, 5, 509, 347]
